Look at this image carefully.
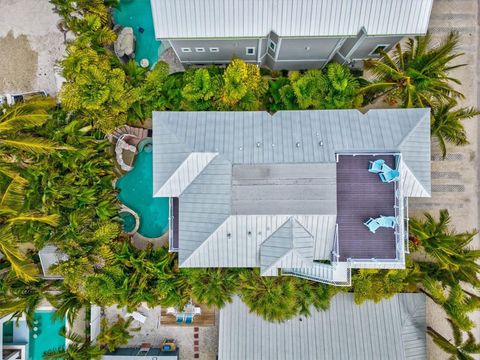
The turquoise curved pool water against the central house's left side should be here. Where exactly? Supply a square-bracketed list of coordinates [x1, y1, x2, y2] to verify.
[116, 139, 169, 238]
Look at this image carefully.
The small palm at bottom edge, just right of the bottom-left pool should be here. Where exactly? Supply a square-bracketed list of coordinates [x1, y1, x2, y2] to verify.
[43, 328, 105, 360]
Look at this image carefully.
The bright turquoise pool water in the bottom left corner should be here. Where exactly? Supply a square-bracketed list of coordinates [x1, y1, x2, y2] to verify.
[28, 310, 65, 360]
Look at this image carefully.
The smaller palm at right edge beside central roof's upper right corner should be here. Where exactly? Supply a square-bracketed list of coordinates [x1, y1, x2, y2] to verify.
[430, 99, 480, 158]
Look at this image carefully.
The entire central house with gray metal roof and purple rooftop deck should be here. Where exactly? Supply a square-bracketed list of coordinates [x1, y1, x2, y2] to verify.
[153, 109, 431, 285]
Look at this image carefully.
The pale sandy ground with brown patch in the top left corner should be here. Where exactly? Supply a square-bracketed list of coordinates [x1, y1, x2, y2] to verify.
[0, 0, 65, 94]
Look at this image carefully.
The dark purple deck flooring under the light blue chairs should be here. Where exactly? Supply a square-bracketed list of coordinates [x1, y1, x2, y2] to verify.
[337, 155, 395, 261]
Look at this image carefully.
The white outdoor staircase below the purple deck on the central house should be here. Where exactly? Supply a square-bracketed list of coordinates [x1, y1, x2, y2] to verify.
[282, 262, 351, 286]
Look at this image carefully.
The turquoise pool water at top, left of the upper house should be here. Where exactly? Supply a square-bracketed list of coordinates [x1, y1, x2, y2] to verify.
[113, 0, 162, 66]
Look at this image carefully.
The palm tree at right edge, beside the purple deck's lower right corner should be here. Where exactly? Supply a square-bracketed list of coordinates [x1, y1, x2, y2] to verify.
[409, 209, 480, 273]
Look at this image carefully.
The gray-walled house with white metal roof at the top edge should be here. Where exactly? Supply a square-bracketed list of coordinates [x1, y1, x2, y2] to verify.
[151, 0, 433, 70]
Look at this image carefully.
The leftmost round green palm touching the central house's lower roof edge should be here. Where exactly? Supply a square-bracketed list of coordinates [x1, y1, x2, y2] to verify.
[186, 268, 239, 308]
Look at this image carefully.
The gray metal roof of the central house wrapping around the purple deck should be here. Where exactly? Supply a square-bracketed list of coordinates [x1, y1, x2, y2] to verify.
[153, 109, 430, 267]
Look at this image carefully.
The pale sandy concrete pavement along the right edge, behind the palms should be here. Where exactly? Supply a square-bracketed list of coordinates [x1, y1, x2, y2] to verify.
[416, 0, 480, 360]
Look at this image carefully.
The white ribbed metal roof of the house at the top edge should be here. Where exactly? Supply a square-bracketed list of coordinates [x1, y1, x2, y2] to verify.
[151, 0, 433, 39]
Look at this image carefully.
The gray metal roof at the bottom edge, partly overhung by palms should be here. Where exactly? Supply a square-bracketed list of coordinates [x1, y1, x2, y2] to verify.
[218, 294, 426, 360]
